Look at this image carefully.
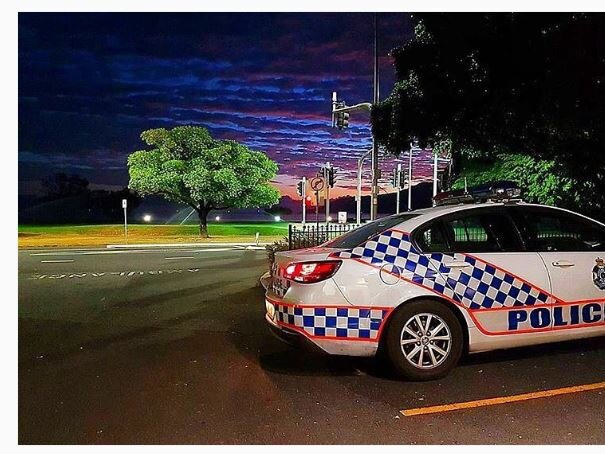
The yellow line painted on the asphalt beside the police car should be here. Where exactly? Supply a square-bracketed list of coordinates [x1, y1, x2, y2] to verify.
[400, 381, 605, 416]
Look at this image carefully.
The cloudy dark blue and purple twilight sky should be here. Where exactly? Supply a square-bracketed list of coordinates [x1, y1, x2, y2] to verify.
[19, 13, 438, 201]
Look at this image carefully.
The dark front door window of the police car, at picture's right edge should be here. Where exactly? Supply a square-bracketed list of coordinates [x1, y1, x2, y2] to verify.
[515, 209, 605, 252]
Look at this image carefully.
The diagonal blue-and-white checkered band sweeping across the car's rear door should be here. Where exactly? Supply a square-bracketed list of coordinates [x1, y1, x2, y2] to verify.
[335, 230, 552, 309]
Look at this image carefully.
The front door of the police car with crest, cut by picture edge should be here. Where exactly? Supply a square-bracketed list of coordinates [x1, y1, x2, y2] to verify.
[511, 206, 605, 330]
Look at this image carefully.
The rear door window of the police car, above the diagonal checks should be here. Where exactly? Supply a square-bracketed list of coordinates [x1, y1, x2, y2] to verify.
[444, 213, 523, 253]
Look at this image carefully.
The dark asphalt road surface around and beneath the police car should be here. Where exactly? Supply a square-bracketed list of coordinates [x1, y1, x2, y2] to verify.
[19, 248, 605, 444]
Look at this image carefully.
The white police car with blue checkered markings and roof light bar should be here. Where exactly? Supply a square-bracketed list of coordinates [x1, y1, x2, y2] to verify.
[264, 186, 605, 380]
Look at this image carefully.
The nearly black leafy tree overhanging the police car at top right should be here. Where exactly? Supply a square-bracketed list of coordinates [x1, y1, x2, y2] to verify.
[372, 13, 605, 219]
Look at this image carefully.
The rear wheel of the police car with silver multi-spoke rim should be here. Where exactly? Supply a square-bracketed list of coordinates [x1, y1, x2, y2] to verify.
[385, 300, 464, 381]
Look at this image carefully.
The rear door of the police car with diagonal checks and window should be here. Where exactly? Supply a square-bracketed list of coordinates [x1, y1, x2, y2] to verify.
[418, 207, 551, 335]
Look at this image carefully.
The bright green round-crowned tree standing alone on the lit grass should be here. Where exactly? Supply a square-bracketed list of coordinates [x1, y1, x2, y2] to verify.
[128, 126, 279, 237]
